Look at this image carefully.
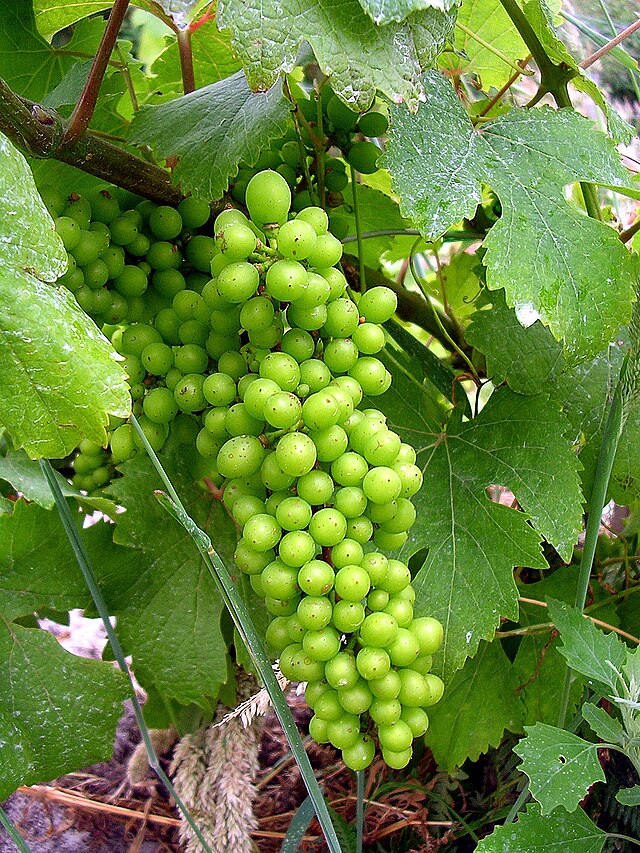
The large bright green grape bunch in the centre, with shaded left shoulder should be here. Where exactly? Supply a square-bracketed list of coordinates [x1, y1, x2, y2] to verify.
[51, 170, 444, 770]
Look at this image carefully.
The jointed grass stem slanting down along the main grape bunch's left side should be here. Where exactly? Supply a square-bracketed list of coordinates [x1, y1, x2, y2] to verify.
[131, 415, 342, 853]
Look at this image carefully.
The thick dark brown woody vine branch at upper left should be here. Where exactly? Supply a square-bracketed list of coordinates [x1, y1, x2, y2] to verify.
[0, 79, 184, 205]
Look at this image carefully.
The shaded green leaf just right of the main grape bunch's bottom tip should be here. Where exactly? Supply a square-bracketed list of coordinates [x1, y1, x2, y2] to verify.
[425, 642, 523, 773]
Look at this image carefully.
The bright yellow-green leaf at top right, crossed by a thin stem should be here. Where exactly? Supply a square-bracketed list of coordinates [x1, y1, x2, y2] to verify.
[455, 0, 529, 91]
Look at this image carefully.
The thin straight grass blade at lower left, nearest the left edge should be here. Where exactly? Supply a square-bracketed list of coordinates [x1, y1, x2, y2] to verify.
[40, 459, 213, 853]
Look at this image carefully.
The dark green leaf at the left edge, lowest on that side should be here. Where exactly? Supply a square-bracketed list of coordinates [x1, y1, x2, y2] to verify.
[0, 612, 129, 799]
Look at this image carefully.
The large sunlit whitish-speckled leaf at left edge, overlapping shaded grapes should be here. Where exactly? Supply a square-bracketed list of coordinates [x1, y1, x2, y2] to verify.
[0, 135, 130, 458]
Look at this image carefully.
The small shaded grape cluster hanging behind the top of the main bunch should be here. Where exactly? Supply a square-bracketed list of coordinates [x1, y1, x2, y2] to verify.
[231, 83, 389, 238]
